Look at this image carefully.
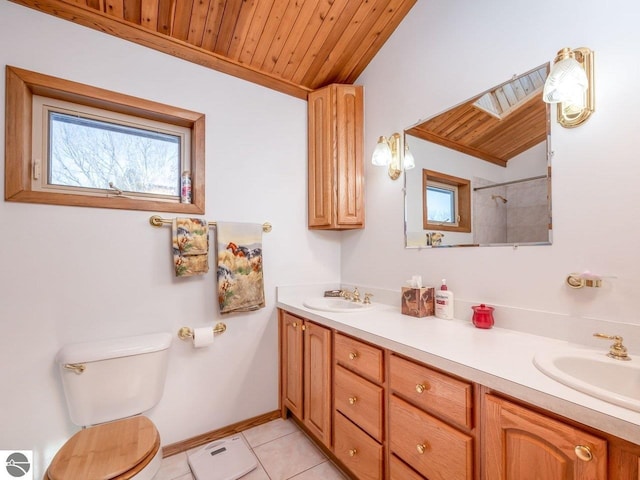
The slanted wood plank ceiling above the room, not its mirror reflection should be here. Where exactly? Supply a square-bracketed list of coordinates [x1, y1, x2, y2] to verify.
[11, 0, 417, 99]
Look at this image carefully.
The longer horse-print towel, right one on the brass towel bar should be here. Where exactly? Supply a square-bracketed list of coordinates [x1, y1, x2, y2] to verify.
[216, 222, 264, 313]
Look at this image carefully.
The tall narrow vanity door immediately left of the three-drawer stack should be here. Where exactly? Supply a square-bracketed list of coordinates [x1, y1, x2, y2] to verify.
[304, 322, 332, 447]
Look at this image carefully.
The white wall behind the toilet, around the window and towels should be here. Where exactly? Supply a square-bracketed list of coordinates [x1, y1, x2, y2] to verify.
[0, 1, 340, 478]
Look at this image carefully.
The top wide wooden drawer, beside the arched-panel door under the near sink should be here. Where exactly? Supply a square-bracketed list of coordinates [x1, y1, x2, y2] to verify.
[389, 355, 473, 428]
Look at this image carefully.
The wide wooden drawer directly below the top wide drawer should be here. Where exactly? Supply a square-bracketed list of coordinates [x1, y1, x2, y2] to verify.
[389, 395, 473, 480]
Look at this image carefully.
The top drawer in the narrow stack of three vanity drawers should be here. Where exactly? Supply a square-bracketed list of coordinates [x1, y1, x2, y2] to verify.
[334, 333, 384, 383]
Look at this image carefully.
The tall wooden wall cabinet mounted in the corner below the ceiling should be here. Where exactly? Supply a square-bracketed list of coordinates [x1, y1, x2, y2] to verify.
[308, 84, 364, 230]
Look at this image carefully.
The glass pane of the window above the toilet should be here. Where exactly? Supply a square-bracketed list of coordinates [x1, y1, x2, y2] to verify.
[48, 111, 182, 196]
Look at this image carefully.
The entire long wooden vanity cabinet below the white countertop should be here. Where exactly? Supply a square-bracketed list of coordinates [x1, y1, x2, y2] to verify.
[279, 310, 640, 480]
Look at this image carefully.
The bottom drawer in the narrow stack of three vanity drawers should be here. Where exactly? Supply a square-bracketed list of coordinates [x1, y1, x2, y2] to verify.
[333, 412, 382, 480]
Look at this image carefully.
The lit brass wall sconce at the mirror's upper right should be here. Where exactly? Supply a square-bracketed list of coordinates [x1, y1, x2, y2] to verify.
[542, 47, 595, 128]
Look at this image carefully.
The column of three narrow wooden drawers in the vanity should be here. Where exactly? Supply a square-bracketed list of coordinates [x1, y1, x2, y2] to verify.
[333, 332, 385, 480]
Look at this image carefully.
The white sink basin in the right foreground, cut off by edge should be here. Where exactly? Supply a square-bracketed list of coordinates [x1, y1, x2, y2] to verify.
[533, 349, 640, 412]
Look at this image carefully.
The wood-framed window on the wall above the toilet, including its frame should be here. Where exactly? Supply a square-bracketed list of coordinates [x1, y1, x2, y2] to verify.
[5, 66, 205, 214]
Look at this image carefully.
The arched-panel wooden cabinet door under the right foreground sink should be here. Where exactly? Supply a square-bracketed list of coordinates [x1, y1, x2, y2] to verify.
[483, 395, 607, 480]
